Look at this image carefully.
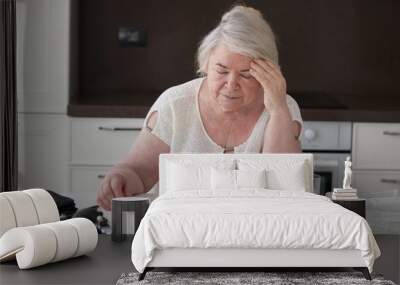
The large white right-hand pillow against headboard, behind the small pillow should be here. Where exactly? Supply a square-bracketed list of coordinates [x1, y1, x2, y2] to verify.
[238, 160, 308, 191]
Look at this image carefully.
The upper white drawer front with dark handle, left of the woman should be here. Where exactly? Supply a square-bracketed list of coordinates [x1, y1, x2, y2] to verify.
[71, 118, 144, 166]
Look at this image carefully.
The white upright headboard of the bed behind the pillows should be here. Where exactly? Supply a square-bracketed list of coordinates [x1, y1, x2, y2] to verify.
[159, 153, 314, 195]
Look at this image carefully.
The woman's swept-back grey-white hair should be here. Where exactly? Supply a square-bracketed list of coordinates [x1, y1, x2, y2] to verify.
[197, 5, 279, 75]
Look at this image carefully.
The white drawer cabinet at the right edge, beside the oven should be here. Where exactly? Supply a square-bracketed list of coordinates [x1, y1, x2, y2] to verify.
[352, 123, 400, 234]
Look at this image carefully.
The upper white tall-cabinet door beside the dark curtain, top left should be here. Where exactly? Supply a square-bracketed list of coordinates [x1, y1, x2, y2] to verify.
[16, 0, 70, 114]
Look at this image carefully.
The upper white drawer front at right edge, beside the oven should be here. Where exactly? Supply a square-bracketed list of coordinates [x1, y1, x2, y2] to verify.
[353, 123, 400, 170]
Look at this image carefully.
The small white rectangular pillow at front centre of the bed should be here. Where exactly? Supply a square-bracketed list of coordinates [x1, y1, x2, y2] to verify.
[211, 168, 267, 190]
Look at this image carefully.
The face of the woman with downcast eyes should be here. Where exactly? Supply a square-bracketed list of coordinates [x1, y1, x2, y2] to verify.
[207, 44, 264, 112]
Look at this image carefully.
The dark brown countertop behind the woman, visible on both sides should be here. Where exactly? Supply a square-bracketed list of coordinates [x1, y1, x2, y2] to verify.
[67, 95, 400, 122]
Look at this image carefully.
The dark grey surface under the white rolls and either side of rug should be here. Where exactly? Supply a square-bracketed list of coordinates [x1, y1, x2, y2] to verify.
[0, 235, 400, 285]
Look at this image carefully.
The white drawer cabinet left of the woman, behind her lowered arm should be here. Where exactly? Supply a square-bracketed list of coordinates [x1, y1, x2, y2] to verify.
[69, 118, 144, 208]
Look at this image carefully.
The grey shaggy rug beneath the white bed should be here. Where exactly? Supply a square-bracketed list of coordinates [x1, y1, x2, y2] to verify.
[117, 271, 395, 285]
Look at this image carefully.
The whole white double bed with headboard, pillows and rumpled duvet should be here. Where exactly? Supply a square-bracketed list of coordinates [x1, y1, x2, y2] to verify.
[132, 154, 380, 280]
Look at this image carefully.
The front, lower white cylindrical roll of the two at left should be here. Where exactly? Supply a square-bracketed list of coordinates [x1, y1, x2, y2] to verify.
[0, 218, 98, 269]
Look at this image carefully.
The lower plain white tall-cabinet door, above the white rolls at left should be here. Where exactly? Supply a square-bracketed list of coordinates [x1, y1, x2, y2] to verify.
[18, 114, 69, 193]
